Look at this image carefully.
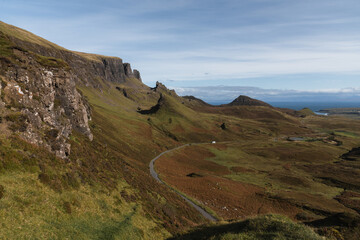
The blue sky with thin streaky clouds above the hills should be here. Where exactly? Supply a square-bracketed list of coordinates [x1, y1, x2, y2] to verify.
[0, 0, 360, 102]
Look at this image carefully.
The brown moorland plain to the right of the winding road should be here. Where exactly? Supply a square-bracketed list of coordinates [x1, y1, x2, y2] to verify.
[155, 115, 360, 239]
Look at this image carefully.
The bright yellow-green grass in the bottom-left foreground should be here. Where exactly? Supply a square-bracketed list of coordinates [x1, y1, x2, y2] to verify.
[0, 173, 169, 239]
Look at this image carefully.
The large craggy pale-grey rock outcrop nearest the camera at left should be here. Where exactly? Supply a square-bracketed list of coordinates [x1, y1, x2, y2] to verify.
[0, 47, 93, 158]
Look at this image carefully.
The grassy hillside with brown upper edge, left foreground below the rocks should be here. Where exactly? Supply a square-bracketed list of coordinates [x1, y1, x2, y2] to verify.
[0, 136, 170, 239]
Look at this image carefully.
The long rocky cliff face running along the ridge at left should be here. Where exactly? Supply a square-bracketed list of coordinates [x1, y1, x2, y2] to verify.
[0, 23, 141, 158]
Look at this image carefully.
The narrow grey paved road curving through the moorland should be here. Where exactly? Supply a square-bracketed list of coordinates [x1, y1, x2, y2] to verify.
[149, 144, 218, 222]
